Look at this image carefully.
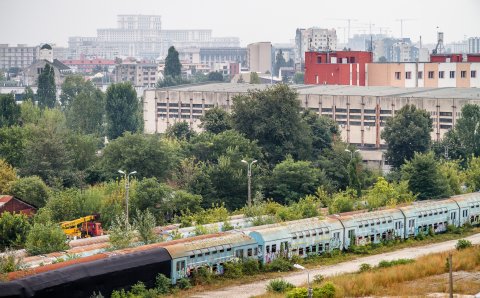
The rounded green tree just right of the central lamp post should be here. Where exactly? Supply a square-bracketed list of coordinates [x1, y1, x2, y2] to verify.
[269, 156, 325, 203]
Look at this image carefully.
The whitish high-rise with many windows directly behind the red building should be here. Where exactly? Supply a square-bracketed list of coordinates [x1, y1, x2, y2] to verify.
[295, 27, 337, 70]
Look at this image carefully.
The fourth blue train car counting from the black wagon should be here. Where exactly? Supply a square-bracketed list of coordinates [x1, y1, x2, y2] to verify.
[398, 199, 460, 238]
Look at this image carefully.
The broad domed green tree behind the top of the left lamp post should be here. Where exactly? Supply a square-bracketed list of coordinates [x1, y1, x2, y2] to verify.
[100, 133, 182, 181]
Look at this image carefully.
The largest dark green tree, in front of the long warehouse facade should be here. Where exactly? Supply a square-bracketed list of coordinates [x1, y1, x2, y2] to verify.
[232, 84, 312, 165]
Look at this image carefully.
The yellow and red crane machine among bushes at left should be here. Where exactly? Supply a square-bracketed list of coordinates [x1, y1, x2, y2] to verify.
[60, 214, 103, 239]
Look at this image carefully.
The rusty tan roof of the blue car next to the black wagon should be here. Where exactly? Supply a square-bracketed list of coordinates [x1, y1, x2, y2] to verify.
[162, 231, 256, 259]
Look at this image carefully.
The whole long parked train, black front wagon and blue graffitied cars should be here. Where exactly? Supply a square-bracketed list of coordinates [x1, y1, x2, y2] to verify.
[0, 192, 480, 297]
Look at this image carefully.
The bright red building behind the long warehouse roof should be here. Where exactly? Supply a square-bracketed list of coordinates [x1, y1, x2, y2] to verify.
[305, 51, 373, 86]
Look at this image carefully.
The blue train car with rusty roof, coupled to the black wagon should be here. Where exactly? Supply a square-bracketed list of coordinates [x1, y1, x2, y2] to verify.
[163, 231, 258, 284]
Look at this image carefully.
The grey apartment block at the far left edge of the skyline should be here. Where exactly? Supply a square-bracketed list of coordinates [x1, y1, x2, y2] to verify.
[0, 44, 40, 69]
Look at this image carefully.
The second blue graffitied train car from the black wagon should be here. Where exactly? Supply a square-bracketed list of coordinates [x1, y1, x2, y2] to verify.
[249, 218, 344, 263]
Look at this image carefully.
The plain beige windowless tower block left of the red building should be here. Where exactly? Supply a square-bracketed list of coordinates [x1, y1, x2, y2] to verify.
[247, 42, 272, 73]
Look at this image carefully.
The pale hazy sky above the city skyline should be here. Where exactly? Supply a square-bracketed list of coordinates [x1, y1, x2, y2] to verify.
[0, 0, 480, 46]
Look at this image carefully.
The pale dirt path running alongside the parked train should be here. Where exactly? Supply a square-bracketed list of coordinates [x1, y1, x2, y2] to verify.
[191, 234, 480, 298]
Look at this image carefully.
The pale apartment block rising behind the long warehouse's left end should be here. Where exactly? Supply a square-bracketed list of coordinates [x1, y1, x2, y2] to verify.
[114, 61, 159, 88]
